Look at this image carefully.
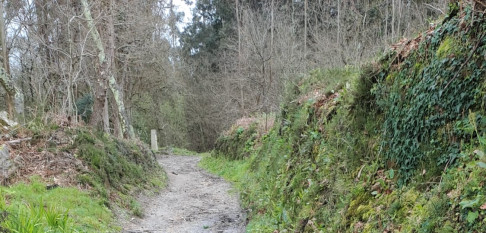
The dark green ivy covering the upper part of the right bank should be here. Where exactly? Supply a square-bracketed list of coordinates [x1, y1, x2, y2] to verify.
[372, 3, 486, 184]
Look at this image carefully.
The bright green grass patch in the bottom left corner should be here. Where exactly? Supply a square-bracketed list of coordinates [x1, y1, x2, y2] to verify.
[0, 177, 114, 233]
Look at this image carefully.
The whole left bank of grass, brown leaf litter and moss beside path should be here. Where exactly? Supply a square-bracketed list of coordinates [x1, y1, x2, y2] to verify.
[0, 120, 166, 232]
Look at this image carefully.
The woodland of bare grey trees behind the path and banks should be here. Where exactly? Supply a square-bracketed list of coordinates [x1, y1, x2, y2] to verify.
[0, 0, 448, 151]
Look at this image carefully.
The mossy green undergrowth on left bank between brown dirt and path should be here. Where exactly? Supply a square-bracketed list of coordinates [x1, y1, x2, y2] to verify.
[73, 130, 166, 215]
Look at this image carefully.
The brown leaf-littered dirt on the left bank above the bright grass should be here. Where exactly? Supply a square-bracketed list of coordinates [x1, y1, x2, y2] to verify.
[0, 125, 89, 189]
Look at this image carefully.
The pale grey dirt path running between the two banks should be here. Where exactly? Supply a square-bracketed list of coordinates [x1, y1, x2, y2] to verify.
[124, 155, 245, 233]
